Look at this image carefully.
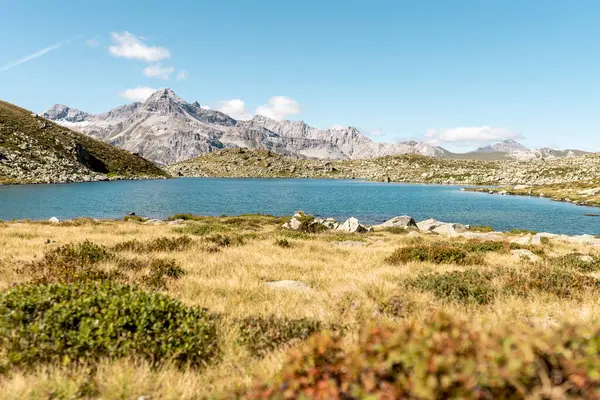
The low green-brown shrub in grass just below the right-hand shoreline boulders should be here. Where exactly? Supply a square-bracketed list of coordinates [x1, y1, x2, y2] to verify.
[386, 244, 483, 265]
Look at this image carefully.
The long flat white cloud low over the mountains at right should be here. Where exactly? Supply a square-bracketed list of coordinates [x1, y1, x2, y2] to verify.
[425, 126, 521, 144]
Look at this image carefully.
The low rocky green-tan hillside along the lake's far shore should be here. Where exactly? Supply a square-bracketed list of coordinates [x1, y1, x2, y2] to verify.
[168, 149, 600, 185]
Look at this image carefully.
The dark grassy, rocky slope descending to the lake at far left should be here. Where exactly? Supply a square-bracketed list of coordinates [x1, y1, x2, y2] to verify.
[0, 101, 168, 183]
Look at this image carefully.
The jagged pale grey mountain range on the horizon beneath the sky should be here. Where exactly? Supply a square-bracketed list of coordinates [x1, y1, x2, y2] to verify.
[42, 89, 583, 165]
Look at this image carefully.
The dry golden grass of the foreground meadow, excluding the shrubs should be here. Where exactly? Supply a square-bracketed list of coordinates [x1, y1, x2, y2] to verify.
[0, 217, 600, 399]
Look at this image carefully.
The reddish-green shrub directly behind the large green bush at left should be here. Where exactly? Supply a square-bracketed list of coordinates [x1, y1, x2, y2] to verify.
[25, 240, 121, 284]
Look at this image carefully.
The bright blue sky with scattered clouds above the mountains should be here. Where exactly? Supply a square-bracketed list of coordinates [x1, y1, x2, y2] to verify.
[0, 0, 600, 151]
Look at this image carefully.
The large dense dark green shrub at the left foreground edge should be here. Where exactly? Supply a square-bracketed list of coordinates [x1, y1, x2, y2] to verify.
[0, 283, 217, 370]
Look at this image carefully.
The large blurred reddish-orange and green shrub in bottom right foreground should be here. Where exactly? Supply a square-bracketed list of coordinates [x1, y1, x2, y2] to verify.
[244, 314, 600, 399]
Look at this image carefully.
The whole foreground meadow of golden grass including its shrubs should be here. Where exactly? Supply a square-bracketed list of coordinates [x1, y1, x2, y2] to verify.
[0, 215, 600, 400]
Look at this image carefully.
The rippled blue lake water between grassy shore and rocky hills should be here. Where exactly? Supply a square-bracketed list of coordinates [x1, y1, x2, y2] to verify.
[0, 178, 600, 234]
